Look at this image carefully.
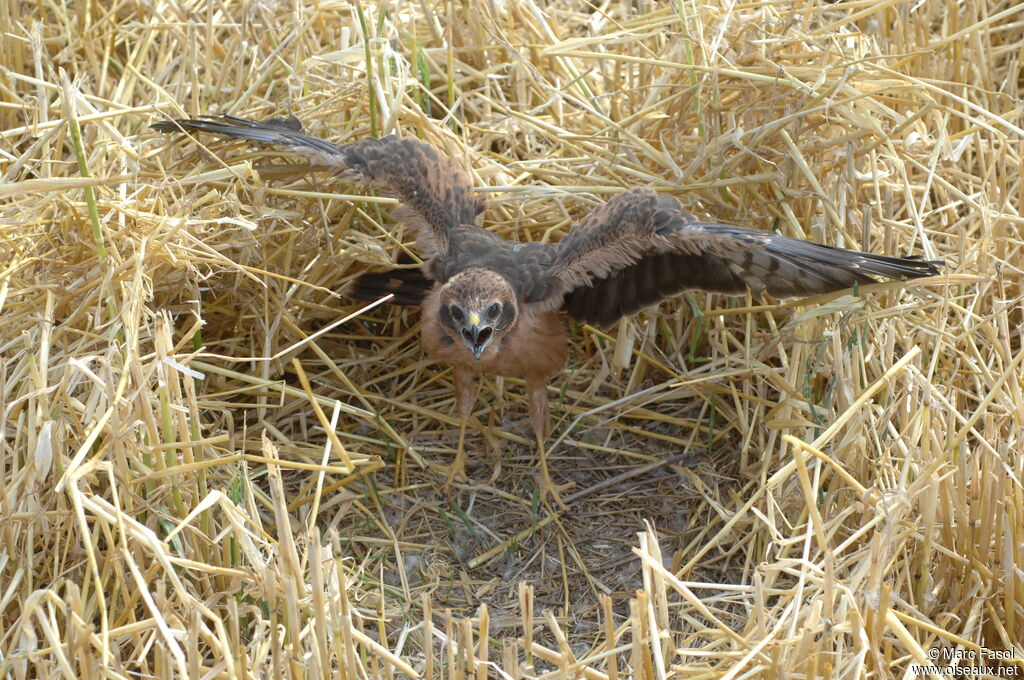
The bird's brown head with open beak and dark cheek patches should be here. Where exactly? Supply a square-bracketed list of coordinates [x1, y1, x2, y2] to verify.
[439, 267, 518, 362]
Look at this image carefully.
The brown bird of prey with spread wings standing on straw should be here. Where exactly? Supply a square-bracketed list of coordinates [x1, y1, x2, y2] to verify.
[153, 116, 943, 500]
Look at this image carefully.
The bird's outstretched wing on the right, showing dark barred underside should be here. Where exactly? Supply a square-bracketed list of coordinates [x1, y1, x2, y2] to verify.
[546, 189, 943, 327]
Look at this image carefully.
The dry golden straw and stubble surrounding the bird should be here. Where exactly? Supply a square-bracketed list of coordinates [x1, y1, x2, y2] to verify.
[0, 0, 1024, 680]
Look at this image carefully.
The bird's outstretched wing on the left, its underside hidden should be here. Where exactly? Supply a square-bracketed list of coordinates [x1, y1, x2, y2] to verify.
[152, 116, 483, 256]
